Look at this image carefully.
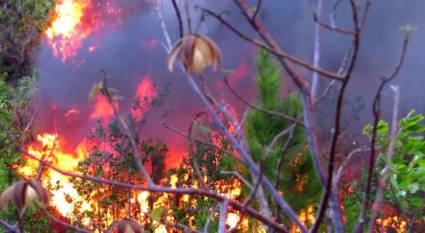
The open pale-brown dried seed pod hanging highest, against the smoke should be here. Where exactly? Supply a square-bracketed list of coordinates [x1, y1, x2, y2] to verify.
[167, 34, 221, 74]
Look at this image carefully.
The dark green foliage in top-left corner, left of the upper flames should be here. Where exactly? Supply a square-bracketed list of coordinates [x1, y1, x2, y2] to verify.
[0, 0, 54, 80]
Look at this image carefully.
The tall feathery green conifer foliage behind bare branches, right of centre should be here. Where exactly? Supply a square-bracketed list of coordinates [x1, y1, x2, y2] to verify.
[246, 51, 320, 215]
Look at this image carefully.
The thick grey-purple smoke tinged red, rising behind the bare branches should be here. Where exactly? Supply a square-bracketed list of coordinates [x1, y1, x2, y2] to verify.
[35, 0, 425, 162]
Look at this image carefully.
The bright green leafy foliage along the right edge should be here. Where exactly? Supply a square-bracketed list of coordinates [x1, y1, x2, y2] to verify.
[350, 110, 425, 230]
